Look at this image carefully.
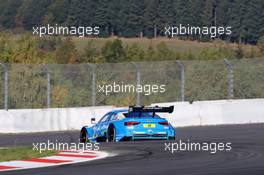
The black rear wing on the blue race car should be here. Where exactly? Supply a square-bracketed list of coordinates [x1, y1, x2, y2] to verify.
[129, 106, 174, 116]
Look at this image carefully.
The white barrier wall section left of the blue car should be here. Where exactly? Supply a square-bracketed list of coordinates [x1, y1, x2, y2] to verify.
[0, 106, 114, 133]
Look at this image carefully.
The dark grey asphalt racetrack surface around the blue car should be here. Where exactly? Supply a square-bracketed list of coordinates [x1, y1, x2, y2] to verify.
[0, 124, 264, 175]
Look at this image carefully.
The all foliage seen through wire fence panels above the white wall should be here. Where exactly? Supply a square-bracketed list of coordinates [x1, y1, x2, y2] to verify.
[3, 59, 264, 109]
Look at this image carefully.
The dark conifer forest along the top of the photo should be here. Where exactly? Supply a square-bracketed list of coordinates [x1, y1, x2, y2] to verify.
[0, 0, 264, 44]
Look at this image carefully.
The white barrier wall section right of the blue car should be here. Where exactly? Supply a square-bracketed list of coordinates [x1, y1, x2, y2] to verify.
[153, 99, 264, 127]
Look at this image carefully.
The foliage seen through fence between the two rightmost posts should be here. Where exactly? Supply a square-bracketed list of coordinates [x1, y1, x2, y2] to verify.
[183, 60, 228, 101]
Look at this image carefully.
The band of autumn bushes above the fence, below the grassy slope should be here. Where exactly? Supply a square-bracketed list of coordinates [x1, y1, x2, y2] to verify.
[0, 33, 258, 64]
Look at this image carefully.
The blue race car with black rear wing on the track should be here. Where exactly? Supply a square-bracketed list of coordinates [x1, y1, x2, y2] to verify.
[80, 106, 175, 143]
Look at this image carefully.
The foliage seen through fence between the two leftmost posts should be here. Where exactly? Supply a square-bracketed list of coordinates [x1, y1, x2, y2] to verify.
[9, 64, 47, 109]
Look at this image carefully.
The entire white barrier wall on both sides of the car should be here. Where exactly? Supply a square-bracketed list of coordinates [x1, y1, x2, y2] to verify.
[0, 99, 264, 133]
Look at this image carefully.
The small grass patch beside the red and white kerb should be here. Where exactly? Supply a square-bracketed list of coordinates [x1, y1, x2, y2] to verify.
[0, 147, 57, 162]
